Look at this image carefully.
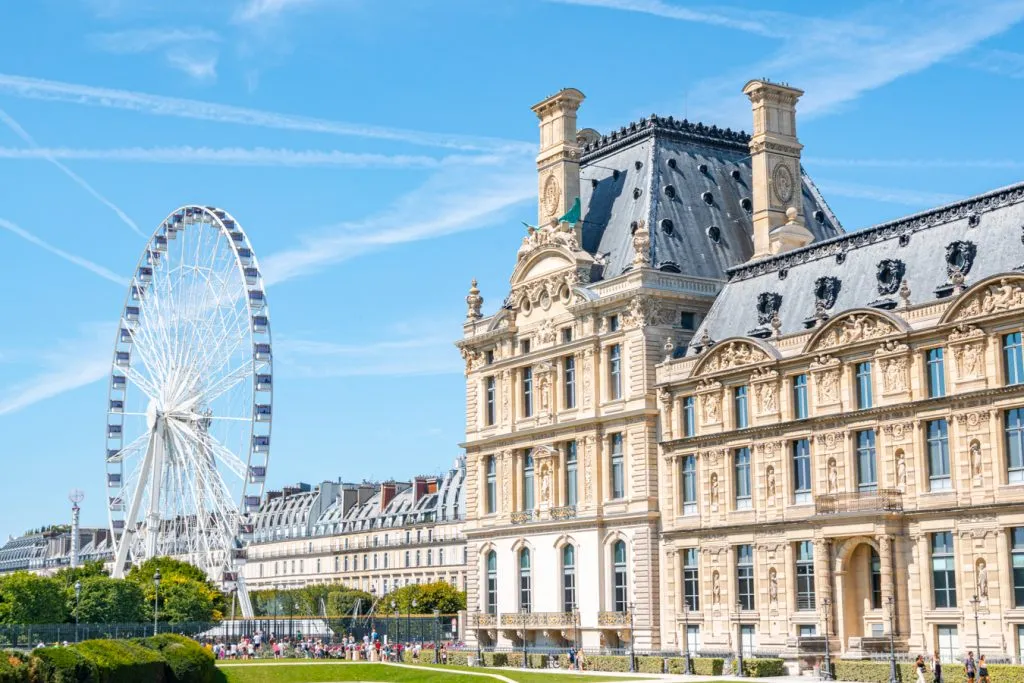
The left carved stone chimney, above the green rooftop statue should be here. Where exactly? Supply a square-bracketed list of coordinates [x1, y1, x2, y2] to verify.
[532, 88, 584, 227]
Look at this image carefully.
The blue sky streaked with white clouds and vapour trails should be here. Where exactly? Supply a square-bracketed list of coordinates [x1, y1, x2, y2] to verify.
[0, 0, 1024, 536]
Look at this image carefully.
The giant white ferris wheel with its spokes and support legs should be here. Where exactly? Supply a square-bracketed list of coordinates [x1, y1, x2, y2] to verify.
[105, 206, 273, 616]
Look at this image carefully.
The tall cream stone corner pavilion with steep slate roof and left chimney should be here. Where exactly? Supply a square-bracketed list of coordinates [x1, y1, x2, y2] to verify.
[458, 83, 842, 649]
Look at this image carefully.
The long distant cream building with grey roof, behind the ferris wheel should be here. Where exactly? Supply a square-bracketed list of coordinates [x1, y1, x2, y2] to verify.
[244, 459, 467, 596]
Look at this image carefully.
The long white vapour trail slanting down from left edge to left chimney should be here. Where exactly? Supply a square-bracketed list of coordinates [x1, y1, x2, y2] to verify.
[0, 74, 536, 153]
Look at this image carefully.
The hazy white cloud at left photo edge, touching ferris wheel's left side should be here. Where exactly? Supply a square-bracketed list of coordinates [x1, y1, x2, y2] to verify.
[0, 323, 114, 416]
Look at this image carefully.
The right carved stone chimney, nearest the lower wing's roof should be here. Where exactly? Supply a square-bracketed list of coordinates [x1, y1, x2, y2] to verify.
[743, 80, 814, 259]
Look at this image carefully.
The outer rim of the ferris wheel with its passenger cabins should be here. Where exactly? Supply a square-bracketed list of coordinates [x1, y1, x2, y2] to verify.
[104, 204, 273, 568]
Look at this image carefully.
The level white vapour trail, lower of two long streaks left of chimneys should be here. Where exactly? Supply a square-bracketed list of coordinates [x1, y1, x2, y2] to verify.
[0, 146, 504, 169]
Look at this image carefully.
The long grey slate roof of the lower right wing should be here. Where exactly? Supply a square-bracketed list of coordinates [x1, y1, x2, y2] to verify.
[691, 183, 1024, 344]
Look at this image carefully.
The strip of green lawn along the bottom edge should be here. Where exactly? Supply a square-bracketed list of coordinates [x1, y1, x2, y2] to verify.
[219, 663, 643, 683]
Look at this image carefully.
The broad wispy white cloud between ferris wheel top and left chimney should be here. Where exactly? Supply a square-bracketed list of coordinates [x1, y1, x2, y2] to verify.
[261, 158, 537, 283]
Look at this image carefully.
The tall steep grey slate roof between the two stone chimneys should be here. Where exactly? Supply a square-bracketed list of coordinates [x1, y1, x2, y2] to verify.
[580, 116, 843, 280]
